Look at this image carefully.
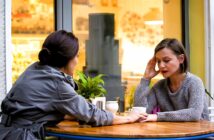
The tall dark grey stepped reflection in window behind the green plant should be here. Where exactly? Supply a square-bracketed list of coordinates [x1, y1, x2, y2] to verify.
[85, 13, 124, 110]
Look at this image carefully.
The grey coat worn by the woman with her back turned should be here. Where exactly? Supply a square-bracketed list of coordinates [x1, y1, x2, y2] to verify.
[0, 62, 113, 140]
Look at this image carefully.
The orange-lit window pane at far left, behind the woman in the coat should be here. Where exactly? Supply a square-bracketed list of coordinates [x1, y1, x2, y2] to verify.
[12, 0, 54, 82]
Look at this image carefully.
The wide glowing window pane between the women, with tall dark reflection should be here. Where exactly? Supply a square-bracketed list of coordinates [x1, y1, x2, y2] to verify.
[72, 0, 163, 109]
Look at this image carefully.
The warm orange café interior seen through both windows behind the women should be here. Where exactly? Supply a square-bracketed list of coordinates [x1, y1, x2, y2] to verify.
[9, 0, 179, 110]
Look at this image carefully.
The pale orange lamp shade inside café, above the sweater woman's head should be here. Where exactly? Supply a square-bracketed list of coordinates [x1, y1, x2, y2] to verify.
[143, 8, 163, 24]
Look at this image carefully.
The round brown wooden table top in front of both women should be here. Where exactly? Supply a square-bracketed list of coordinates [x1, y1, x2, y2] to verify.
[46, 120, 214, 138]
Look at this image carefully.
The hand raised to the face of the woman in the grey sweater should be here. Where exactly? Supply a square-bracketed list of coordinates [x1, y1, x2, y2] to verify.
[143, 57, 159, 80]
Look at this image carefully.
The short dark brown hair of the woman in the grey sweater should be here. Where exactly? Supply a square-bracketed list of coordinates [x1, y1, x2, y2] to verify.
[155, 38, 188, 73]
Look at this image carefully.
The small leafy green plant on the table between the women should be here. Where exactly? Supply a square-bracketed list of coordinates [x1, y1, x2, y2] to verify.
[75, 71, 107, 99]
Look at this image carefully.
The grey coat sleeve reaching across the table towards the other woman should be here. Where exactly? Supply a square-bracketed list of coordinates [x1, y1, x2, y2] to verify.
[54, 81, 113, 126]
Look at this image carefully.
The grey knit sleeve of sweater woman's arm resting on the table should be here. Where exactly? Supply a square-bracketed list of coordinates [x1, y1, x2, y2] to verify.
[157, 79, 205, 121]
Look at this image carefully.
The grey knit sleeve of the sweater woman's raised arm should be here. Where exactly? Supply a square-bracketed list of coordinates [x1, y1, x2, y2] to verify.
[134, 78, 157, 113]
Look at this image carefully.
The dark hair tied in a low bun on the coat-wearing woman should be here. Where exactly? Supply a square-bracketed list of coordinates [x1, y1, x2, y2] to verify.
[39, 30, 79, 68]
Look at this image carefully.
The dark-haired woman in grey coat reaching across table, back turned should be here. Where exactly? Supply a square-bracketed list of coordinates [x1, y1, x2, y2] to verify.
[0, 30, 146, 140]
